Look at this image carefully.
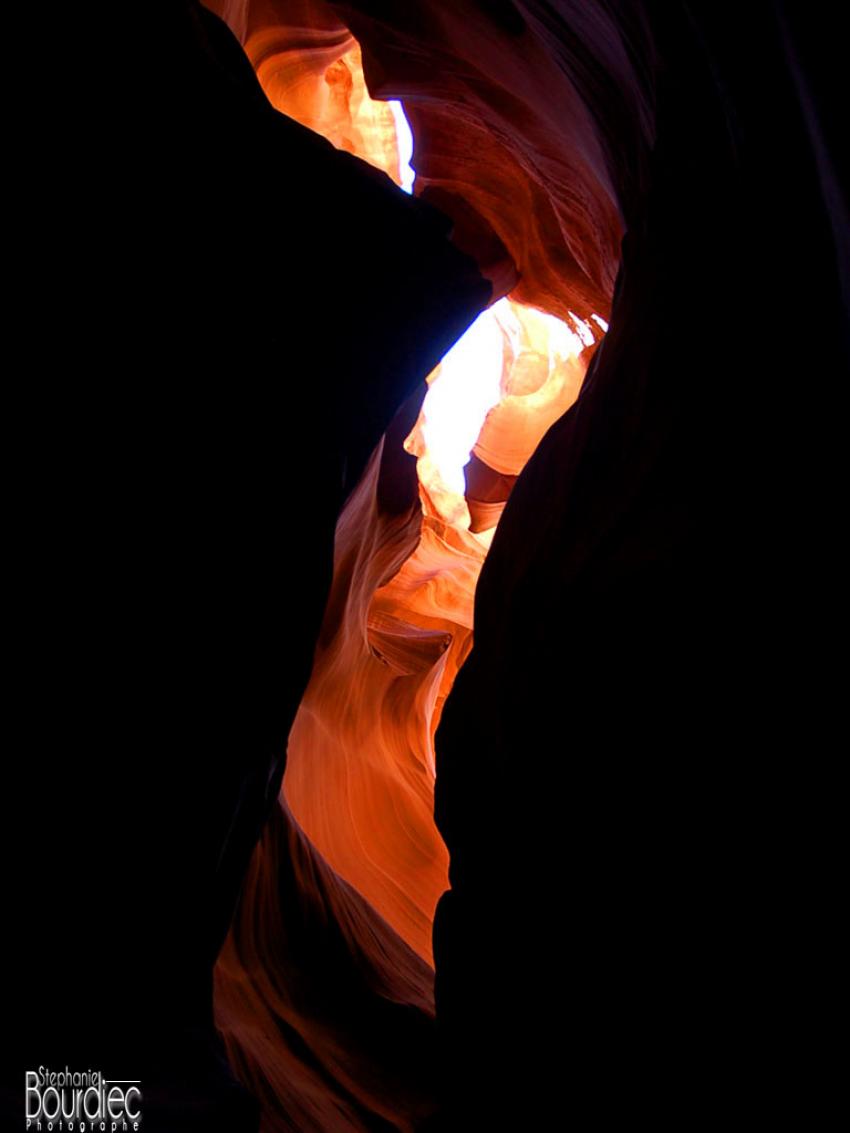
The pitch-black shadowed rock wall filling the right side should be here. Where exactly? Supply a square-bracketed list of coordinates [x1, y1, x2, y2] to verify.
[435, 6, 848, 1128]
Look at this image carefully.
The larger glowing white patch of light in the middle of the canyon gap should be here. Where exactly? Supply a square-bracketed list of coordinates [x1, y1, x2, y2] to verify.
[423, 299, 512, 495]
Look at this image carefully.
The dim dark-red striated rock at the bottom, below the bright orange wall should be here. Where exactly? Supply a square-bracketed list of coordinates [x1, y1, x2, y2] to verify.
[215, 807, 437, 1133]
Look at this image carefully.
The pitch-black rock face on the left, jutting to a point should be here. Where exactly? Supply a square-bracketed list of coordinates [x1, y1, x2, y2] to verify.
[10, 3, 491, 1131]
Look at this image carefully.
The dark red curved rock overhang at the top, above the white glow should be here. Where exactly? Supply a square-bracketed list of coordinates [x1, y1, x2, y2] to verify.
[211, 0, 653, 320]
